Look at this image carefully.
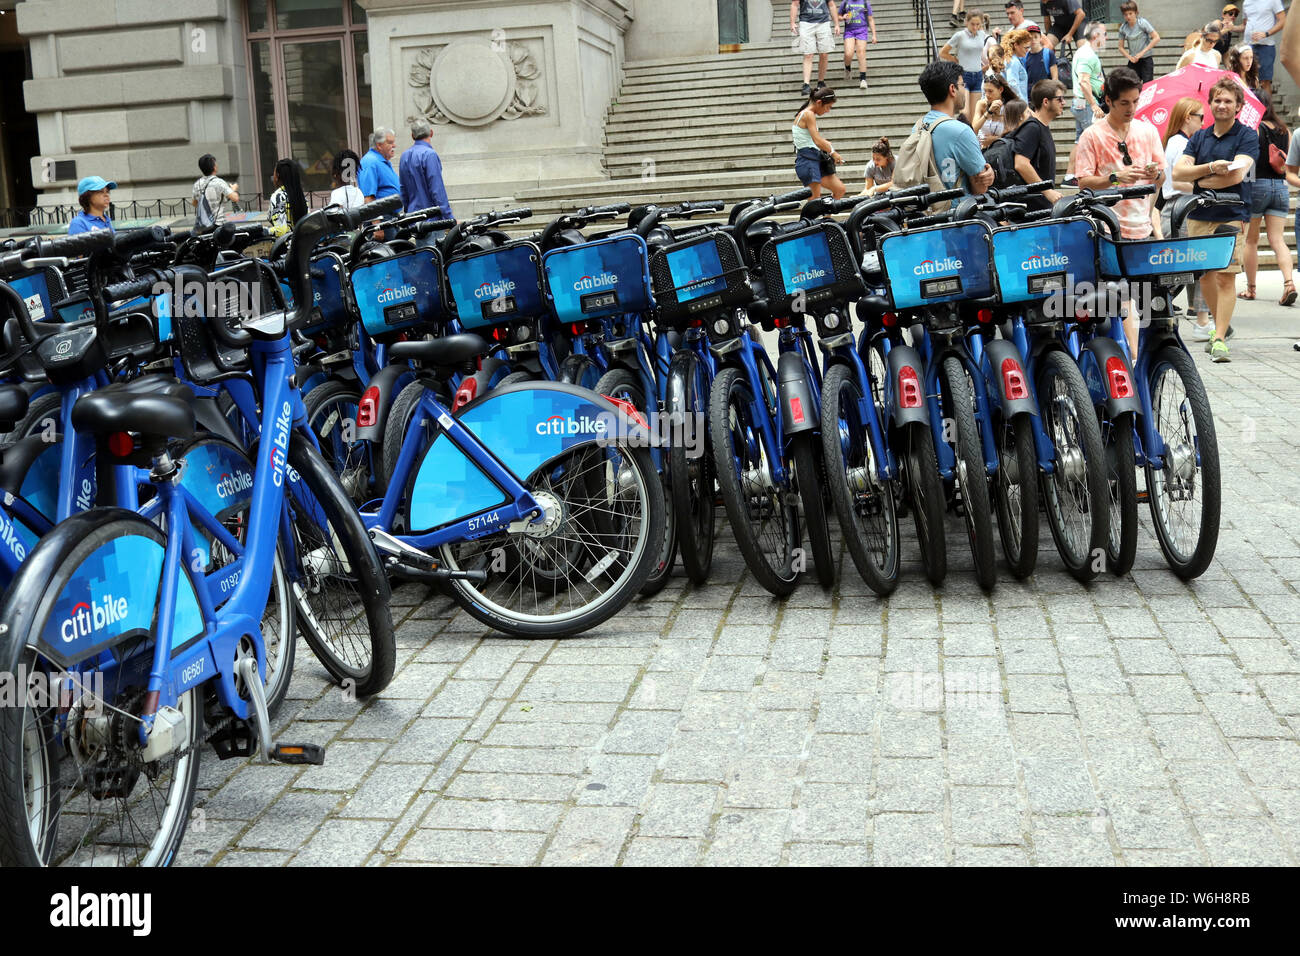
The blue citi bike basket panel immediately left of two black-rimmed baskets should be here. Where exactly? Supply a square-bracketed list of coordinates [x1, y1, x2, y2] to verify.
[542, 234, 654, 323]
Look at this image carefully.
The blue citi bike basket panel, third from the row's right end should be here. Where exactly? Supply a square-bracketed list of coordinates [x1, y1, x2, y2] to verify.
[880, 222, 993, 308]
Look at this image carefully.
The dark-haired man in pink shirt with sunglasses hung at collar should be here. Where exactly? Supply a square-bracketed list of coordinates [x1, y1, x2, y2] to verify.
[1074, 66, 1165, 355]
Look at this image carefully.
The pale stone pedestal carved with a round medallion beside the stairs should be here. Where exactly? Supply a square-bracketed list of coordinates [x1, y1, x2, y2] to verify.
[360, 0, 632, 200]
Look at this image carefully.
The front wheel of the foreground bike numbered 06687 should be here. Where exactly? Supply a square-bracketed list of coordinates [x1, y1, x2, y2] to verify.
[285, 436, 397, 697]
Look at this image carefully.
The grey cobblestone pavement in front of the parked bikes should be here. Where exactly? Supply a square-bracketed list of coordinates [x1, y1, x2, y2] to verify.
[181, 306, 1300, 866]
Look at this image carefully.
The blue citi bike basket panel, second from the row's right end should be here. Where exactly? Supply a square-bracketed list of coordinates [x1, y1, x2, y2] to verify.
[993, 219, 1097, 302]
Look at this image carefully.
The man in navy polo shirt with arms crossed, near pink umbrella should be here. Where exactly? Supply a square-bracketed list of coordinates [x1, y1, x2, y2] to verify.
[1174, 77, 1260, 362]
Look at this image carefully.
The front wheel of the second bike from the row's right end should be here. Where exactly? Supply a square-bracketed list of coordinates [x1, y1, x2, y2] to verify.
[1039, 349, 1110, 581]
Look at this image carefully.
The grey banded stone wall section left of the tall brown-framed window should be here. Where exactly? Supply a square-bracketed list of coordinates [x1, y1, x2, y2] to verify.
[17, 0, 252, 206]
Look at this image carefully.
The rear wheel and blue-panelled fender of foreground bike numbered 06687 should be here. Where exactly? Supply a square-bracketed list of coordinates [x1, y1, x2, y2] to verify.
[0, 509, 203, 866]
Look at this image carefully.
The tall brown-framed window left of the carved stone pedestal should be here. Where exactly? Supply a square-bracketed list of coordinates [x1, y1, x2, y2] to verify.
[244, 0, 373, 195]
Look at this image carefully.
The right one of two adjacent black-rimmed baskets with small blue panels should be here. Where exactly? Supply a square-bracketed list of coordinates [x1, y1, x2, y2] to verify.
[759, 222, 866, 316]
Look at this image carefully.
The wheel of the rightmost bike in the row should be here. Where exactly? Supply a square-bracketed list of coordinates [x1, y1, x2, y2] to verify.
[1147, 343, 1221, 580]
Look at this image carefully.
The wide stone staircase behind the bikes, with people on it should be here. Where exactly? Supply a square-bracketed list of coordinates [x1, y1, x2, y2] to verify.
[452, 0, 1295, 265]
